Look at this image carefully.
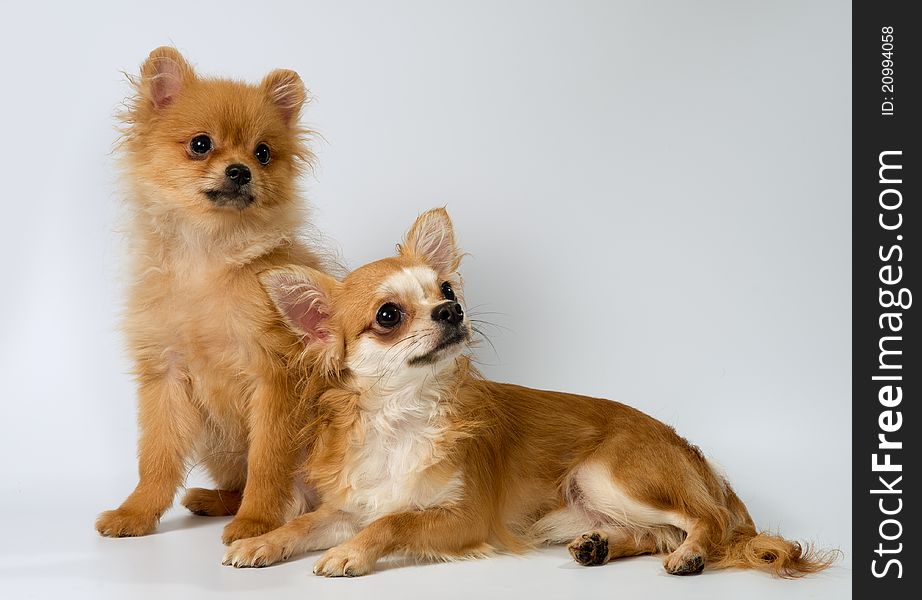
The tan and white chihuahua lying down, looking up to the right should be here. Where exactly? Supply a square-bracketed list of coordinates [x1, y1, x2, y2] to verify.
[224, 210, 834, 577]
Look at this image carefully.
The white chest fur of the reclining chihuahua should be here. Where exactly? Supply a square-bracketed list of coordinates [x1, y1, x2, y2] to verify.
[343, 381, 462, 524]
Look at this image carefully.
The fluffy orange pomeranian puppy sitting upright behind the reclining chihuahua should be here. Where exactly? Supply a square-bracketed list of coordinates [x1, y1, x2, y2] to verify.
[96, 47, 321, 543]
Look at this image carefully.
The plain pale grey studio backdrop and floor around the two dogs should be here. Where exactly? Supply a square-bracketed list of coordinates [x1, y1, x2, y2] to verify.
[0, 0, 851, 598]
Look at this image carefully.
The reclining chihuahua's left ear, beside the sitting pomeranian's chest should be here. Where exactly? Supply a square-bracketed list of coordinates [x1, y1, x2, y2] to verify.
[259, 266, 339, 344]
